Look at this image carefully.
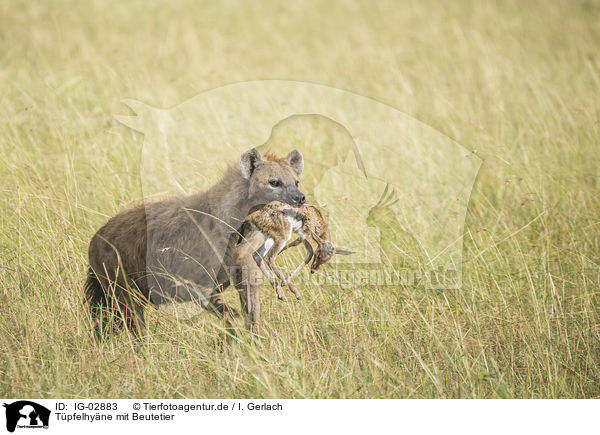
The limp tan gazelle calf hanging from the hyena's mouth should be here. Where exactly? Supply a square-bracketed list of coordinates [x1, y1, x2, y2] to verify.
[240, 201, 353, 300]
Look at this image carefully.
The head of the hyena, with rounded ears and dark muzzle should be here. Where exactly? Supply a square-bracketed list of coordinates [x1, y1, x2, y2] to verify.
[240, 148, 306, 206]
